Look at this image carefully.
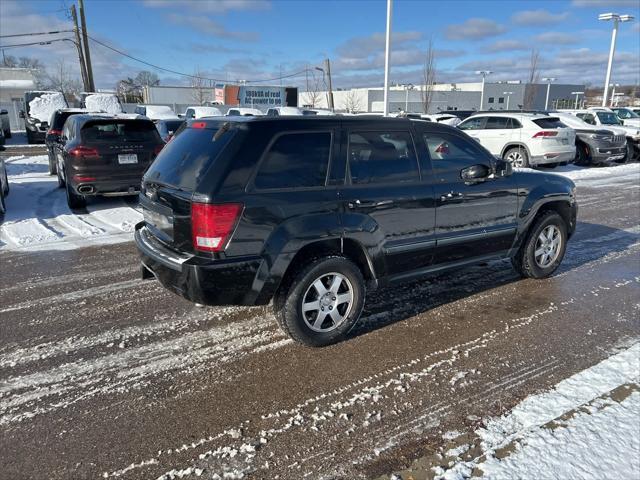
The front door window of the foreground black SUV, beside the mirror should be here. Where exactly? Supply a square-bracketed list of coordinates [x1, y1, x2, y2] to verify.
[422, 133, 490, 181]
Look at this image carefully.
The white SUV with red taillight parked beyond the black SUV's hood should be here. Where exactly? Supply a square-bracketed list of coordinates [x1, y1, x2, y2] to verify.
[458, 112, 576, 167]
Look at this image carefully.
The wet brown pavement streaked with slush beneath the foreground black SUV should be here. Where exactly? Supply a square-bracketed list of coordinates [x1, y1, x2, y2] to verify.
[0, 166, 640, 479]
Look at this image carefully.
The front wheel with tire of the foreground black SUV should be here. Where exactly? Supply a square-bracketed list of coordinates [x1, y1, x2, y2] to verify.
[511, 211, 568, 278]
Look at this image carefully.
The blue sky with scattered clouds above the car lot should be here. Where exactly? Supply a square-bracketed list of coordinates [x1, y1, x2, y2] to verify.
[0, 0, 640, 88]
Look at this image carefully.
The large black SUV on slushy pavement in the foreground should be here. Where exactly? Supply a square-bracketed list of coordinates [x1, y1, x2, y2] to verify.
[135, 117, 577, 346]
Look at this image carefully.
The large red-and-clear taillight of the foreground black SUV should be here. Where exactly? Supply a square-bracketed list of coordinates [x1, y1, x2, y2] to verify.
[191, 202, 243, 252]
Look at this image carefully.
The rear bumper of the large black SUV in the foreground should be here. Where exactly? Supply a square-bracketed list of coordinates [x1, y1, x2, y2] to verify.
[135, 222, 263, 306]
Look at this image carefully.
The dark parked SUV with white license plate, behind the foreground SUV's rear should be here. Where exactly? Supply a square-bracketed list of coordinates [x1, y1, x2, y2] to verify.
[55, 114, 164, 208]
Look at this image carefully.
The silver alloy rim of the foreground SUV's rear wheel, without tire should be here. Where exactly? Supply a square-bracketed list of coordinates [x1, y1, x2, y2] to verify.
[301, 272, 353, 333]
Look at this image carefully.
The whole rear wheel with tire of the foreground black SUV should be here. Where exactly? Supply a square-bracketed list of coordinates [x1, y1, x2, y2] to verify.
[274, 255, 365, 347]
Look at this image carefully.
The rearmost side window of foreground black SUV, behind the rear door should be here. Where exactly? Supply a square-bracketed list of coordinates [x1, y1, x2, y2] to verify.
[254, 132, 331, 189]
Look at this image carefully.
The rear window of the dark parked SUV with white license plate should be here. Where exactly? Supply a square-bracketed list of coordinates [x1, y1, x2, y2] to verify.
[81, 120, 160, 143]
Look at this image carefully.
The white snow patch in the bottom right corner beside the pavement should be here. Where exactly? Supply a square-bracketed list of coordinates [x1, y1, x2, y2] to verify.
[434, 343, 640, 480]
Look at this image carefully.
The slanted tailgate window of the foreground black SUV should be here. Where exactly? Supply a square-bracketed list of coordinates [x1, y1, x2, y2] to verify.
[145, 122, 238, 191]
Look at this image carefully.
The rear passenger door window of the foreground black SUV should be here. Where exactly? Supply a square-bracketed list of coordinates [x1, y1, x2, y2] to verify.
[348, 132, 420, 185]
